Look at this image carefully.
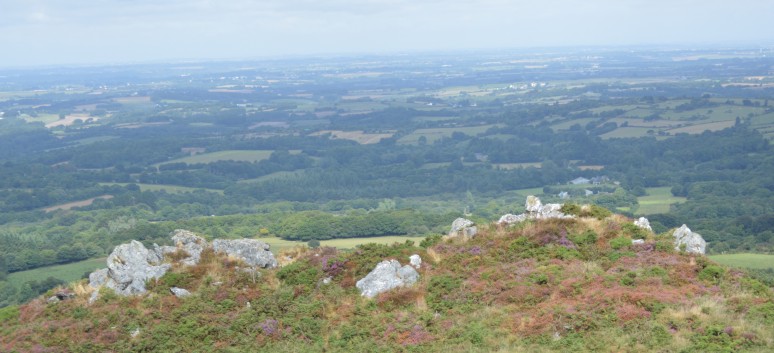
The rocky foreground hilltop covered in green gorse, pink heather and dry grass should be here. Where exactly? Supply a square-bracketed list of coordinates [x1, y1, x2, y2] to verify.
[0, 201, 774, 352]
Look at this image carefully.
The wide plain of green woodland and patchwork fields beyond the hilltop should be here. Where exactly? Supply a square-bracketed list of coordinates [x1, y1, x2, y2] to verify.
[0, 48, 774, 306]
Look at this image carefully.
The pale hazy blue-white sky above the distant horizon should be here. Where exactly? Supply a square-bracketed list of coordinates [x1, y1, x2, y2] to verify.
[0, 0, 774, 67]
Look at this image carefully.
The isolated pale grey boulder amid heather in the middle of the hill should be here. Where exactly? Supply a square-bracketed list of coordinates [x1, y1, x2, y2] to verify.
[355, 260, 419, 298]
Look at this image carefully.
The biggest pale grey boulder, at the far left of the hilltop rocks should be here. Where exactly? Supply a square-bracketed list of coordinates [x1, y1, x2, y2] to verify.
[101, 240, 171, 295]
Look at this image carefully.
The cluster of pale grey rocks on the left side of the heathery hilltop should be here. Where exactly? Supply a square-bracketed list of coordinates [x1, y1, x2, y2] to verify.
[89, 229, 277, 301]
